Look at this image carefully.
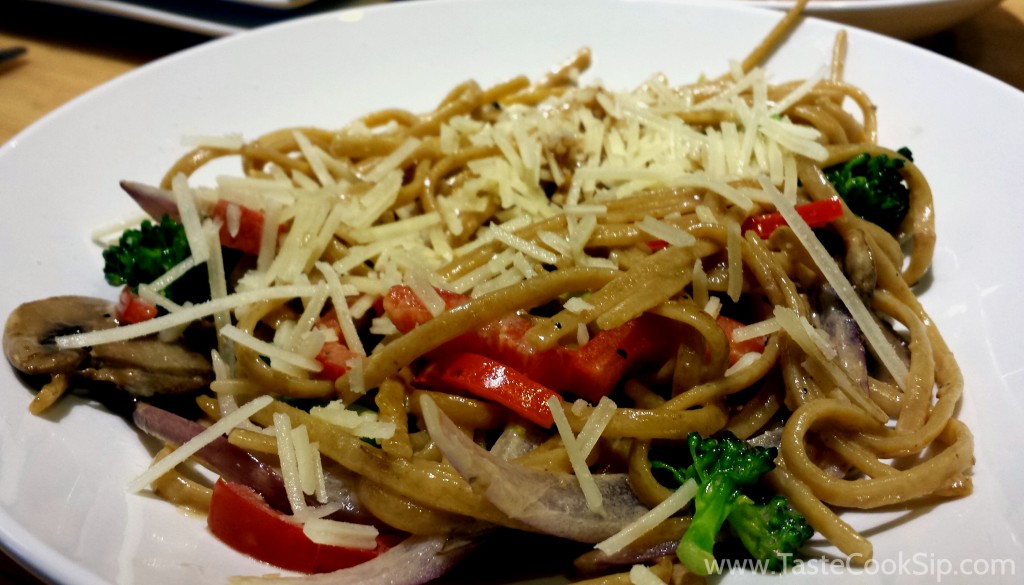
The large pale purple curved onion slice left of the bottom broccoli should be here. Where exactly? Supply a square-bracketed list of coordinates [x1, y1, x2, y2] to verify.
[422, 395, 647, 543]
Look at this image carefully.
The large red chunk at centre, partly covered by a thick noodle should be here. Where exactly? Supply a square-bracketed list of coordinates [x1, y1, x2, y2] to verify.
[384, 287, 671, 402]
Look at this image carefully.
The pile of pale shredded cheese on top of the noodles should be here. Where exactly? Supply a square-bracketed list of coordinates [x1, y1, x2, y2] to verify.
[61, 58, 825, 375]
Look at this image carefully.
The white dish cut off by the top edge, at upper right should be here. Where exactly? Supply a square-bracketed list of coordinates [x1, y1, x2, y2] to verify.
[757, 0, 1001, 40]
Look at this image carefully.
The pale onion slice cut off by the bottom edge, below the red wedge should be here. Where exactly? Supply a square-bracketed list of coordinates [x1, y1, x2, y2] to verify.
[231, 536, 473, 585]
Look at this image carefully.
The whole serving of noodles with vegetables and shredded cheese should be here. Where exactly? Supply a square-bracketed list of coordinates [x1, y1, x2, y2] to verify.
[4, 2, 974, 584]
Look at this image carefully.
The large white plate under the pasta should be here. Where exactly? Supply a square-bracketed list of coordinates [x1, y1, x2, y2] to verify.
[0, 0, 1024, 585]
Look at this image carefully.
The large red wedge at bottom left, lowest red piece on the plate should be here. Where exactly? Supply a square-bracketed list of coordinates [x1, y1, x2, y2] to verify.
[207, 479, 389, 573]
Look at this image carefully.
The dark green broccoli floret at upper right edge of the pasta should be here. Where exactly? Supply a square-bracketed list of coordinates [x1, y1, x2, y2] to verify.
[824, 147, 913, 233]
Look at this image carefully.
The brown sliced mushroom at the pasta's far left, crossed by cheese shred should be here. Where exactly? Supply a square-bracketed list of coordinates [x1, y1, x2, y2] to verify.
[3, 296, 213, 396]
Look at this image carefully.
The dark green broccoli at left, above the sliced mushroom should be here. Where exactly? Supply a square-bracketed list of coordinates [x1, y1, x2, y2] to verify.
[103, 215, 209, 302]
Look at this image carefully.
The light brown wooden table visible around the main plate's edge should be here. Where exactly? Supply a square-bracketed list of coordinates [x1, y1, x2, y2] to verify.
[0, 0, 1024, 585]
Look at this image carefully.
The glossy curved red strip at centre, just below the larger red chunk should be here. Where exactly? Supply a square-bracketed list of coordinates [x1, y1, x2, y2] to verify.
[417, 353, 558, 428]
